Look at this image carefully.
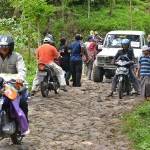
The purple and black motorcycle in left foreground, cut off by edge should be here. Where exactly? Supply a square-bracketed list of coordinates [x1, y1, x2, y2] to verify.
[0, 77, 29, 144]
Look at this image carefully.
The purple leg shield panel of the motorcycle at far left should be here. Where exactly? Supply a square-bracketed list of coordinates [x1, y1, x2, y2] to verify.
[10, 96, 29, 134]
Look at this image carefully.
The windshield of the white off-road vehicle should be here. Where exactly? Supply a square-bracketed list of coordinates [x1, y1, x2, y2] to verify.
[104, 34, 141, 48]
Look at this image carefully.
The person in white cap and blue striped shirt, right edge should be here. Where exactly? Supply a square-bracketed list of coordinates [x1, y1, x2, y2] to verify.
[138, 46, 150, 99]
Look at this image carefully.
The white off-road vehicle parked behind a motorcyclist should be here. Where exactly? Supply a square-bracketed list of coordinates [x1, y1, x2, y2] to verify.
[92, 31, 145, 82]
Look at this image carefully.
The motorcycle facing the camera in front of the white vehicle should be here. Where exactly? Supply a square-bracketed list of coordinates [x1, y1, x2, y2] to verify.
[115, 56, 133, 99]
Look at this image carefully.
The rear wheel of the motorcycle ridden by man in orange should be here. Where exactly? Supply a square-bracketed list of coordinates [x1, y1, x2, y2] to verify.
[40, 77, 49, 97]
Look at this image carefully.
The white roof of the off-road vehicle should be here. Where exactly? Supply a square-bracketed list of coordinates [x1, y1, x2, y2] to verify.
[107, 30, 145, 35]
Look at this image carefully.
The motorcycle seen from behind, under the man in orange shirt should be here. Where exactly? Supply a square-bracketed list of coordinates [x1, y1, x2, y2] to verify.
[38, 64, 60, 97]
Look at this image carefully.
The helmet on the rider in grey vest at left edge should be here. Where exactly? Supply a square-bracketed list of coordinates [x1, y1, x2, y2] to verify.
[0, 35, 14, 52]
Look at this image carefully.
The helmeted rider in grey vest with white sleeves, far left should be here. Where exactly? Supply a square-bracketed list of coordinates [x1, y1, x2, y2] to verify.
[0, 35, 29, 134]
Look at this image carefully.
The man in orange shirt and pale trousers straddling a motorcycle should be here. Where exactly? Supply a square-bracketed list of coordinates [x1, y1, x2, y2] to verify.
[31, 36, 67, 96]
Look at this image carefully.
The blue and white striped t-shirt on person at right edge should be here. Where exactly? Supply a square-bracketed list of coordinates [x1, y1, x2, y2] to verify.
[139, 56, 150, 76]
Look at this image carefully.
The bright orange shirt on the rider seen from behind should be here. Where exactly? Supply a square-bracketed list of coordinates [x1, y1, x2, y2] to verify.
[36, 44, 59, 64]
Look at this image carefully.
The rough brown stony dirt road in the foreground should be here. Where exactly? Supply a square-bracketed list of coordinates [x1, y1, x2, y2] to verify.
[0, 80, 140, 150]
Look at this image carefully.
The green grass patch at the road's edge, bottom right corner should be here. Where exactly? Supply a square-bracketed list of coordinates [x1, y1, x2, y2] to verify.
[123, 101, 150, 150]
